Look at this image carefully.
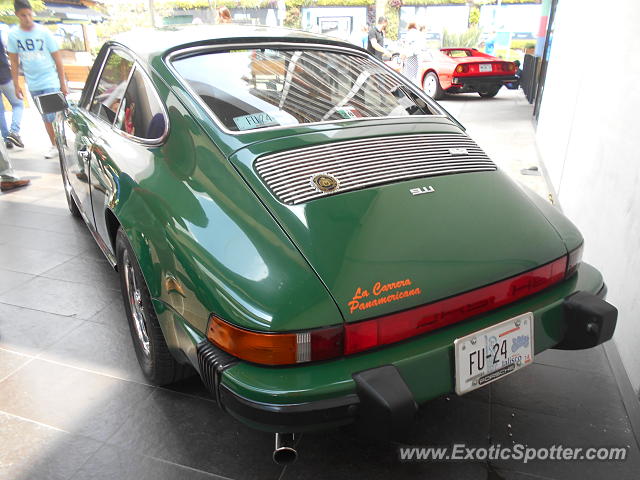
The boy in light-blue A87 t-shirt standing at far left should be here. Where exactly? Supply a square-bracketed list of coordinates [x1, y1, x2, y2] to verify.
[7, 0, 69, 158]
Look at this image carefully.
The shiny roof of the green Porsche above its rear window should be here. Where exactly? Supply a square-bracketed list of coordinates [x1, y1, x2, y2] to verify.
[113, 24, 362, 62]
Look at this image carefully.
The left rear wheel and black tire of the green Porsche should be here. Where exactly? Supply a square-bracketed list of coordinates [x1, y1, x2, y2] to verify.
[116, 228, 193, 385]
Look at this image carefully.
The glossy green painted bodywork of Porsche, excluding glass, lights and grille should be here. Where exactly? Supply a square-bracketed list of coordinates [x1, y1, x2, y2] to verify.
[56, 25, 616, 431]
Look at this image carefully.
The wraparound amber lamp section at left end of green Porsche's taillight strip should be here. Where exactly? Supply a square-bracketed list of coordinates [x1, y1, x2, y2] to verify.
[207, 315, 344, 365]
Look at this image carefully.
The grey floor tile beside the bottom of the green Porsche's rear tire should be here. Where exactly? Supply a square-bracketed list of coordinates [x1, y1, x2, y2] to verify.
[41, 322, 148, 383]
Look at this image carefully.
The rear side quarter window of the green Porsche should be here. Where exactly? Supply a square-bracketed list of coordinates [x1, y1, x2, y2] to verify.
[115, 68, 166, 140]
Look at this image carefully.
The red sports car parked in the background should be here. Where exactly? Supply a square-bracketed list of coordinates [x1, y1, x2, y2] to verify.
[419, 48, 516, 100]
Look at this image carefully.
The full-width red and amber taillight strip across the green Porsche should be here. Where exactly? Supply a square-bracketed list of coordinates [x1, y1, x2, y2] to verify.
[207, 258, 568, 365]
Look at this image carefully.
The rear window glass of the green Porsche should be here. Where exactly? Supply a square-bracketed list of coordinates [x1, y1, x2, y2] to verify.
[173, 49, 439, 131]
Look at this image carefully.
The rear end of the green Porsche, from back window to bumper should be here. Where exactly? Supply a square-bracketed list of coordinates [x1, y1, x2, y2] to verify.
[168, 38, 616, 435]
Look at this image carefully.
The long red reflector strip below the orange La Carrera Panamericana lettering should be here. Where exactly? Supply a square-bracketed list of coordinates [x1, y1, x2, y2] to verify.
[344, 256, 567, 355]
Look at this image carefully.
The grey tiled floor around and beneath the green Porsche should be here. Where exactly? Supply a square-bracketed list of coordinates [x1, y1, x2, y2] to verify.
[0, 92, 640, 480]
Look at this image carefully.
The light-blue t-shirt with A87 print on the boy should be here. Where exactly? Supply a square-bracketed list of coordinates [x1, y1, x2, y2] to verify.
[7, 23, 60, 92]
